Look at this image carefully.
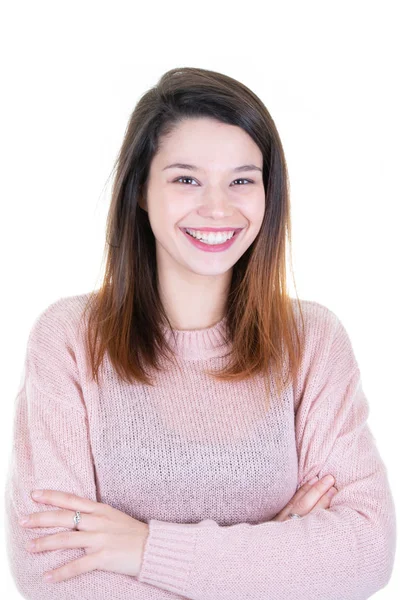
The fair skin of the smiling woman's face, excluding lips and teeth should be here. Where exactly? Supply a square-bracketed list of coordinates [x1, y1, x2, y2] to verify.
[140, 117, 265, 276]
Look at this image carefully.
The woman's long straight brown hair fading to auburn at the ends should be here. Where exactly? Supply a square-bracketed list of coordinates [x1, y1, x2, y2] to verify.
[84, 67, 304, 408]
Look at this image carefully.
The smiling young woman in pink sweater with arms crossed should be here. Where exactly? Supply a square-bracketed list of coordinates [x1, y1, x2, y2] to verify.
[6, 68, 396, 600]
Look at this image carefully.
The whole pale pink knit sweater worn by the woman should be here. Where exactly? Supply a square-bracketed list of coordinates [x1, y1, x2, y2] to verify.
[5, 294, 396, 600]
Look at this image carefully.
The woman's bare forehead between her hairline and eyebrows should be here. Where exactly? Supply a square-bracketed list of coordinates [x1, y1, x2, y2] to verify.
[154, 117, 262, 168]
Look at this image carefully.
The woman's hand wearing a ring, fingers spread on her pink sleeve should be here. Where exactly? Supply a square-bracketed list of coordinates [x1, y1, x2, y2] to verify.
[20, 490, 149, 582]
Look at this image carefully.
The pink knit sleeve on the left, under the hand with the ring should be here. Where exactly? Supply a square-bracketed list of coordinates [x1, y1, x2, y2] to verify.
[4, 301, 186, 600]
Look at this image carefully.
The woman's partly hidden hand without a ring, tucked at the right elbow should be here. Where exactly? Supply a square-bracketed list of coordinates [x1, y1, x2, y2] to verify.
[271, 477, 337, 521]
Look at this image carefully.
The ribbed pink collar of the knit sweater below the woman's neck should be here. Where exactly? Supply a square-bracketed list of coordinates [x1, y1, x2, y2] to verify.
[162, 315, 228, 360]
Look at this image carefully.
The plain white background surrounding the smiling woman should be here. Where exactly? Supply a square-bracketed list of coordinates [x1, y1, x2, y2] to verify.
[0, 0, 400, 600]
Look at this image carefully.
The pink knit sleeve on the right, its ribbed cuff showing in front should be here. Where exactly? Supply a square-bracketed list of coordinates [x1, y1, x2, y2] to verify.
[138, 311, 396, 600]
